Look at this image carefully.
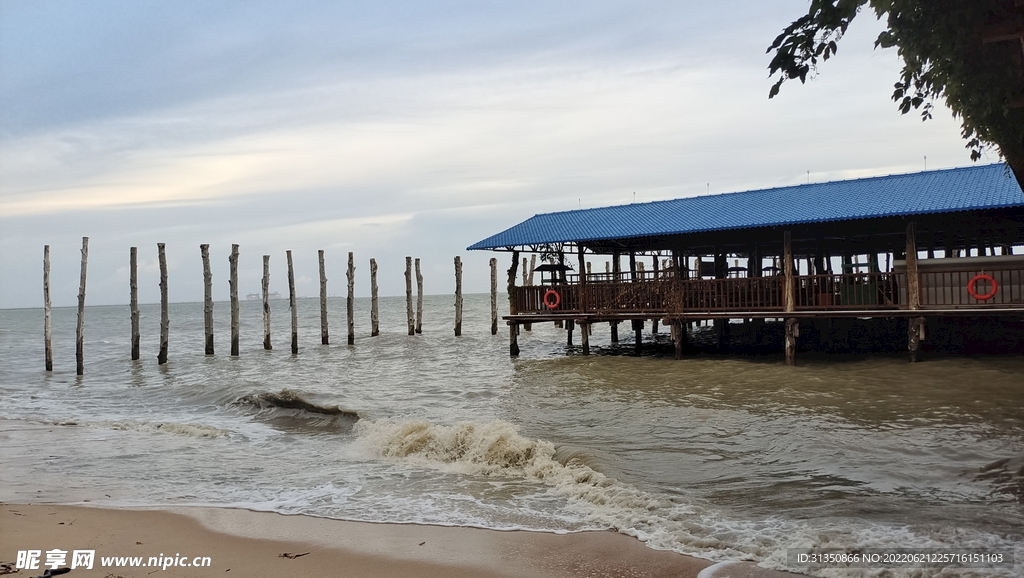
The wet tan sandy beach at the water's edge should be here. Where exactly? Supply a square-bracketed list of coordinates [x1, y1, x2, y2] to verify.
[0, 503, 786, 578]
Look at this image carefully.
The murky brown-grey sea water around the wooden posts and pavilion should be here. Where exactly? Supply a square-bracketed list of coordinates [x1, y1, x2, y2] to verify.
[0, 295, 1024, 576]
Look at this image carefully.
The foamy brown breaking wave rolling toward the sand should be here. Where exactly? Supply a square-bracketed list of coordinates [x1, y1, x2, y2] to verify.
[354, 419, 1021, 578]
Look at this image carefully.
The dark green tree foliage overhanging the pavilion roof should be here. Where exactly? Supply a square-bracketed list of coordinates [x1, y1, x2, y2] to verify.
[768, 0, 1024, 187]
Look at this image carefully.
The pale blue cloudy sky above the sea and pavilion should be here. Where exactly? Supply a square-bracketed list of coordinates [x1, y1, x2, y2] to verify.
[0, 0, 997, 307]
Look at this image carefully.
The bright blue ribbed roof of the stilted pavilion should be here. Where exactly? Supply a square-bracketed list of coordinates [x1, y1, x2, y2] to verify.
[468, 164, 1024, 250]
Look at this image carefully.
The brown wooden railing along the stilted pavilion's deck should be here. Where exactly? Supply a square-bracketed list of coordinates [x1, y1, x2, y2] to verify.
[512, 269, 1024, 315]
